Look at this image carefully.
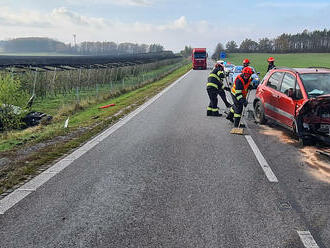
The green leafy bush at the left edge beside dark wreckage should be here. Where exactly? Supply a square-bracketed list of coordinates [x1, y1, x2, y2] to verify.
[0, 75, 29, 131]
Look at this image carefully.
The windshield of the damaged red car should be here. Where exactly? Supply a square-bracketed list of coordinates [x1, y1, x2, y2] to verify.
[300, 73, 330, 98]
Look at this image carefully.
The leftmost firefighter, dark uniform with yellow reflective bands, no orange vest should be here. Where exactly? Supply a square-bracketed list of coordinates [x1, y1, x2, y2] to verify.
[206, 62, 231, 116]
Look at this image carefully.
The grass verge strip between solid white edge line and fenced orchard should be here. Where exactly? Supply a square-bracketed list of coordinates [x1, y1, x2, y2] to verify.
[0, 64, 191, 194]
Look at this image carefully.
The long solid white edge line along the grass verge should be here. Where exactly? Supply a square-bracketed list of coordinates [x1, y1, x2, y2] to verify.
[0, 70, 192, 215]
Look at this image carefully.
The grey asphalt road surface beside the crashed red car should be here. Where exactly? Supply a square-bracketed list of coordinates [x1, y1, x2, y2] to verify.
[0, 71, 330, 248]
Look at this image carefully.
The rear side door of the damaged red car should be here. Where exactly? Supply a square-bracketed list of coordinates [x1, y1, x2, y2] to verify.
[262, 72, 284, 120]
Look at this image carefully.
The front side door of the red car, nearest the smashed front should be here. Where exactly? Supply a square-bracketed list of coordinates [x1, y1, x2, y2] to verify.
[276, 72, 297, 128]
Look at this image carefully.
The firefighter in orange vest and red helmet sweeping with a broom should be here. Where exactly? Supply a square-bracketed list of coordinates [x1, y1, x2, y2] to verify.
[226, 67, 253, 127]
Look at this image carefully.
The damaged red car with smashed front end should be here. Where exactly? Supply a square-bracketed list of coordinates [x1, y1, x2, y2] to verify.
[253, 67, 330, 145]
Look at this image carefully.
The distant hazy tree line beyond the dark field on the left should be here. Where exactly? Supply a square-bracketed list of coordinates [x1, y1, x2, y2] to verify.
[0, 37, 164, 55]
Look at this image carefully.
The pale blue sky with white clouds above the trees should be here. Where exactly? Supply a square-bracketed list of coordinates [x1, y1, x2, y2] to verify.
[0, 0, 330, 51]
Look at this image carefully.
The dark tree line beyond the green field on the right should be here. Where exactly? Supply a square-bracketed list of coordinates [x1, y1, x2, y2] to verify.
[226, 29, 330, 53]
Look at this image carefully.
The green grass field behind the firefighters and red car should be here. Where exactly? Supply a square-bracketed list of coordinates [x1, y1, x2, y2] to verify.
[226, 53, 330, 77]
